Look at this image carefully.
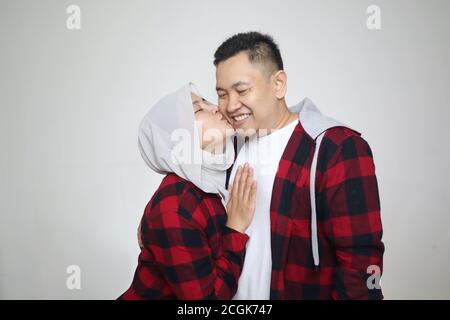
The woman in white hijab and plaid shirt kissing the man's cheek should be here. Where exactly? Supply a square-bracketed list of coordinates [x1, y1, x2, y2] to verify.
[119, 84, 256, 299]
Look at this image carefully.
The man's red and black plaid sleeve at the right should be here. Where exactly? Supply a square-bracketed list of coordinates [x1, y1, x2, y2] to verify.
[319, 129, 384, 299]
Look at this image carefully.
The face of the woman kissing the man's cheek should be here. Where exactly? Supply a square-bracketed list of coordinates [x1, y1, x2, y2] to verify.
[191, 93, 235, 152]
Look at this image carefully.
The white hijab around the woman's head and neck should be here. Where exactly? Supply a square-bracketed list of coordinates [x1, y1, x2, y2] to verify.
[138, 83, 234, 206]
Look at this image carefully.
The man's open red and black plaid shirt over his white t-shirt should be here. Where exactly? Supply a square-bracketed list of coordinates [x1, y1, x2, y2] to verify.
[270, 122, 384, 299]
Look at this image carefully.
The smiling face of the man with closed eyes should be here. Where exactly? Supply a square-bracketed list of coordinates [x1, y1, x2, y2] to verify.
[216, 52, 278, 131]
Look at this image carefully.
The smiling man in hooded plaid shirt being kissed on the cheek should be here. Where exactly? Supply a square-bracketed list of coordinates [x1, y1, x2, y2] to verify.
[214, 32, 384, 299]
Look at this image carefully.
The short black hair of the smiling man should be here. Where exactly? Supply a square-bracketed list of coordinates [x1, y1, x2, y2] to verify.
[214, 32, 283, 71]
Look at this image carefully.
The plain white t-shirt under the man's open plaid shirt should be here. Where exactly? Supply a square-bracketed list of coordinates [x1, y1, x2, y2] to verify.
[230, 120, 298, 300]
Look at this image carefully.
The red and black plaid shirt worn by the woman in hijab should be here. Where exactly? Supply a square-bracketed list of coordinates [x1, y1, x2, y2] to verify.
[119, 174, 248, 300]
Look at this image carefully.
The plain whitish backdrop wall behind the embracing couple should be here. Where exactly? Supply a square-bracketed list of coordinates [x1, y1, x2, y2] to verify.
[0, 0, 450, 299]
